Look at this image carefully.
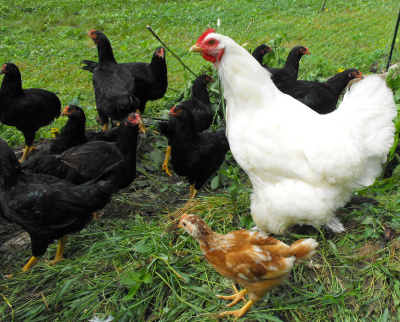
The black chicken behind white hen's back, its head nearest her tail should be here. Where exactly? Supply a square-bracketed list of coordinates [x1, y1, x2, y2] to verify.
[276, 69, 363, 114]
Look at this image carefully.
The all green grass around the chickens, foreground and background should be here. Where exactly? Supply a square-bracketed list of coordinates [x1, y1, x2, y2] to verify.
[0, 0, 400, 321]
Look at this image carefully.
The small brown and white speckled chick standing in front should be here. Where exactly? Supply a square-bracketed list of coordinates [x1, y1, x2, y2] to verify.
[178, 214, 318, 318]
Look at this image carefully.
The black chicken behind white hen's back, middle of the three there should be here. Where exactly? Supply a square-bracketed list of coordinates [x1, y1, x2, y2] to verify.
[267, 46, 310, 85]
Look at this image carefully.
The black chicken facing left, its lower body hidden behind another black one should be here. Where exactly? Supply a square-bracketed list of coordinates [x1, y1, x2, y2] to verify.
[50, 105, 119, 154]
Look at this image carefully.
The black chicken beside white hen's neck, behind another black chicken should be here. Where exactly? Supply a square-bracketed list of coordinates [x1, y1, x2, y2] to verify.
[162, 74, 214, 176]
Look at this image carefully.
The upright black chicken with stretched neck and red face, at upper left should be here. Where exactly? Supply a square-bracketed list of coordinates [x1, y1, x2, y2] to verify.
[88, 30, 140, 130]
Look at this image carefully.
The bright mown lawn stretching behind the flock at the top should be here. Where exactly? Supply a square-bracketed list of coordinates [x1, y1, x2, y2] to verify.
[0, 0, 400, 115]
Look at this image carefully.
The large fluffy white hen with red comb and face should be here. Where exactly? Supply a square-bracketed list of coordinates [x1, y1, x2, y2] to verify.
[190, 29, 396, 234]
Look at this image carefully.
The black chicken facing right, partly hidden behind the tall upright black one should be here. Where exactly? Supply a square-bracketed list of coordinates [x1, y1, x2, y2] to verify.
[82, 47, 168, 114]
